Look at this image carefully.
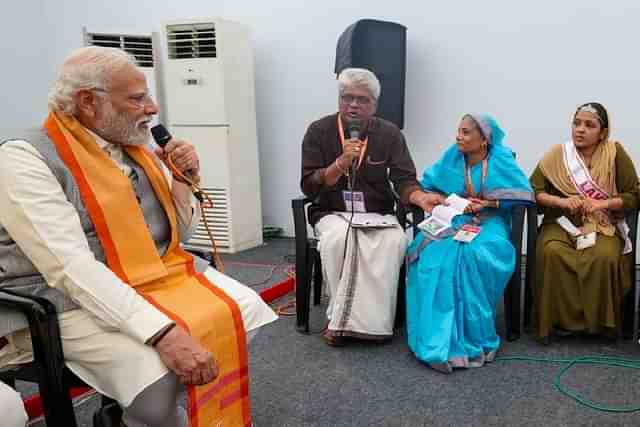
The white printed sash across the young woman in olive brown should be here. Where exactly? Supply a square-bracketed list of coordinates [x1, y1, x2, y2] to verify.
[562, 141, 632, 255]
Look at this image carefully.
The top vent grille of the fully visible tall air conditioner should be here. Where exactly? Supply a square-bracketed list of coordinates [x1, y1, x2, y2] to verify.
[167, 23, 218, 59]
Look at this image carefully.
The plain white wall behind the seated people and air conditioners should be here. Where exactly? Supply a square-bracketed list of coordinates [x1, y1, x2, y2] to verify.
[0, 0, 640, 233]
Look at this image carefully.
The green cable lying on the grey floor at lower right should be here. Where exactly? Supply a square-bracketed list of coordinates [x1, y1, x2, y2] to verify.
[496, 356, 640, 413]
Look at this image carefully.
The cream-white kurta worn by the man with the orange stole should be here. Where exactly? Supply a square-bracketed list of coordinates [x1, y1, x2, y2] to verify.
[0, 137, 277, 406]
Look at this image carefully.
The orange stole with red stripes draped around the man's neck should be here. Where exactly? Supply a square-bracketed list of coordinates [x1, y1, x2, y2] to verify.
[44, 113, 251, 427]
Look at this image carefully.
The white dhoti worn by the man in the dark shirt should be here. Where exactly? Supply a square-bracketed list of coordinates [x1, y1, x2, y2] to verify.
[315, 215, 409, 339]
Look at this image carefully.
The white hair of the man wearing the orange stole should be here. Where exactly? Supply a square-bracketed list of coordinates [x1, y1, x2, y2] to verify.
[49, 46, 137, 115]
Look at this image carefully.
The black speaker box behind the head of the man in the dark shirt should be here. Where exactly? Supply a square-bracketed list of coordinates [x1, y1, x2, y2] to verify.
[335, 19, 407, 129]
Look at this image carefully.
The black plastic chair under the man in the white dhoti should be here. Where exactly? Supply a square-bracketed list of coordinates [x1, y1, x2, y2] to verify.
[291, 197, 410, 334]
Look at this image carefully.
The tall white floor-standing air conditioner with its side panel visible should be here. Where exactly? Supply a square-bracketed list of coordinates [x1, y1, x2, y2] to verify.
[162, 18, 262, 253]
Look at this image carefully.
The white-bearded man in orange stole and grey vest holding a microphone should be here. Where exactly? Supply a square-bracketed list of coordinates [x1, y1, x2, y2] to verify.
[0, 47, 276, 427]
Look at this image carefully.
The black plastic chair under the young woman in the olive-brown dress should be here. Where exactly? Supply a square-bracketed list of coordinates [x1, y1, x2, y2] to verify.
[524, 206, 640, 342]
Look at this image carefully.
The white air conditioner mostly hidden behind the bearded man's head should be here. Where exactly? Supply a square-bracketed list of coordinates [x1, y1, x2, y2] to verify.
[82, 27, 164, 124]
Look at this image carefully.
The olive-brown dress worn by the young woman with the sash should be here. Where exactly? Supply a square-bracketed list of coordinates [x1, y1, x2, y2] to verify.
[531, 143, 638, 339]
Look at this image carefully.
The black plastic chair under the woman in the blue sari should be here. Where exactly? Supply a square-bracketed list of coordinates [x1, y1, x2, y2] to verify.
[412, 206, 525, 341]
